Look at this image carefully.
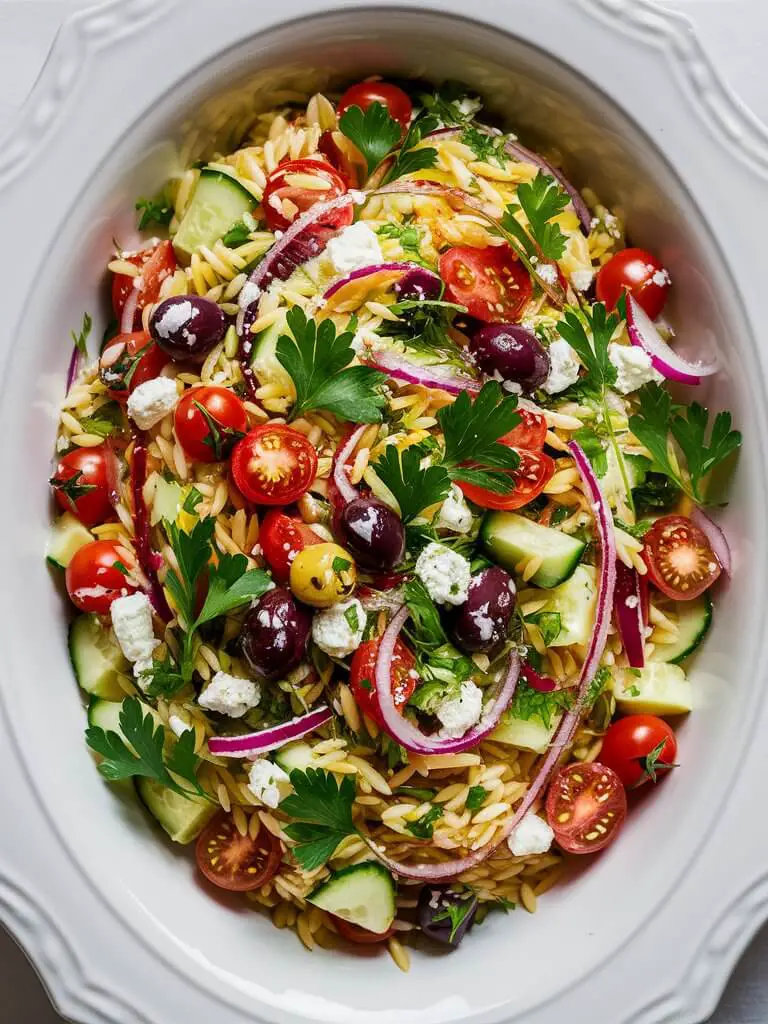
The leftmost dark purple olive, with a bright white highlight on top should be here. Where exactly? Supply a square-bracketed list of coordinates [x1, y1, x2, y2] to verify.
[150, 295, 226, 361]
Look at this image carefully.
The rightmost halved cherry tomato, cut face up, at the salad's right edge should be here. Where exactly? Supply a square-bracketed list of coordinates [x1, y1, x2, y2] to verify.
[643, 515, 722, 601]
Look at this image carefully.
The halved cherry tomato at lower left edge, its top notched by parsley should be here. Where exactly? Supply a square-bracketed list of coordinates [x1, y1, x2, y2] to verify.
[195, 814, 283, 893]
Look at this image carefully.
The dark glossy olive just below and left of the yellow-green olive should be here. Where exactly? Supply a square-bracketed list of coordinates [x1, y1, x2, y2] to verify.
[240, 587, 312, 679]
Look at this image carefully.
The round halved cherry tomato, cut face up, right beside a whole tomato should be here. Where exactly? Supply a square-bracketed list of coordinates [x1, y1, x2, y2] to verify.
[231, 423, 317, 505]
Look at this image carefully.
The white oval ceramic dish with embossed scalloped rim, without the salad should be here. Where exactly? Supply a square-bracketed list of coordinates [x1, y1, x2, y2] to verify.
[0, 0, 768, 1024]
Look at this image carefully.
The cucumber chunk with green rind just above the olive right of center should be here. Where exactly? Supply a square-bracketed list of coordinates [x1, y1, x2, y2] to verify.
[480, 512, 586, 589]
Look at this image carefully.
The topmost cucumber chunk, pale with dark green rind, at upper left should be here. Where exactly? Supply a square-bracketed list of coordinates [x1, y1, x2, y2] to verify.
[173, 167, 259, 257]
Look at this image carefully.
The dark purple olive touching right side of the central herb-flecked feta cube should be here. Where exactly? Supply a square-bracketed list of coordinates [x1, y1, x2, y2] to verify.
[451, 565, 515, 651]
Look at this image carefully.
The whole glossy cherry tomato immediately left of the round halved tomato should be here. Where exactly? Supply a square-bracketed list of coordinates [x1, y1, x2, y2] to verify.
[173, 387, 248, 462]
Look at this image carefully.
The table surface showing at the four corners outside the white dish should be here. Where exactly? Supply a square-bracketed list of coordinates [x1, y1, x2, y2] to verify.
[0, 0, 768, 1024]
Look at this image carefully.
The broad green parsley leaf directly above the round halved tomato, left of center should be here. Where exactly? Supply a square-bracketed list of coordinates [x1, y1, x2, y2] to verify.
[278, 309, 387, 423]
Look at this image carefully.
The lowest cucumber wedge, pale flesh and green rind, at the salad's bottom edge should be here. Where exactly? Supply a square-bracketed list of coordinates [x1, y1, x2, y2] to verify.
[307, 860, 395, 934]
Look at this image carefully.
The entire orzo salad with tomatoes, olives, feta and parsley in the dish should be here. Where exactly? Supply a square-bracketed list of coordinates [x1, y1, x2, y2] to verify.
[47, 81, 741, 969]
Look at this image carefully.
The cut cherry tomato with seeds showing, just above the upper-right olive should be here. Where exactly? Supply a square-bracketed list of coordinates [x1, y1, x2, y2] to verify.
[439, 245, 534, 323]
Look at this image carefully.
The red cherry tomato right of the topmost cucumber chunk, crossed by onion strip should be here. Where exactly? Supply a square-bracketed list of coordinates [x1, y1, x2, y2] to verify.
[261, 160, 354, 231]
